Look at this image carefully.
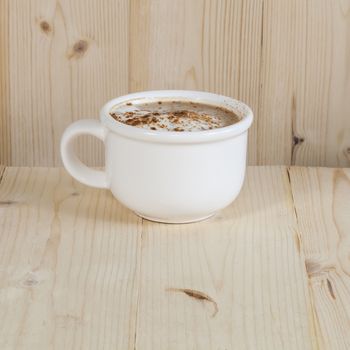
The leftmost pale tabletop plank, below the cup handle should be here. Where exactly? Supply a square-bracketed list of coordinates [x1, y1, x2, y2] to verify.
[0, 168, 141, 350]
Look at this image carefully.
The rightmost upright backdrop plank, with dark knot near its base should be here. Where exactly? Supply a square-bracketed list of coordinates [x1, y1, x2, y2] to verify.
[257, 0, 350, 166]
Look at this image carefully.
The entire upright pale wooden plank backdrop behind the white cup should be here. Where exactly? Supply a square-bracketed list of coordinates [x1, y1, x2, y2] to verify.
[0, 0, 350, 166]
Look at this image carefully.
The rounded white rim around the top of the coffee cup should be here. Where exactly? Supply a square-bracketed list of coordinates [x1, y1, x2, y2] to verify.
[100, 90, 253, 143]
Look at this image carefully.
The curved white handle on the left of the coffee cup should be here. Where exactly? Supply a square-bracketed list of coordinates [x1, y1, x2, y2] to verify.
[61, 119, 108, 188]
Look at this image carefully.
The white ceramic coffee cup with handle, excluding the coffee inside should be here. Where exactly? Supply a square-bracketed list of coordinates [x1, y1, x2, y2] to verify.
[61, 90, 253, 223]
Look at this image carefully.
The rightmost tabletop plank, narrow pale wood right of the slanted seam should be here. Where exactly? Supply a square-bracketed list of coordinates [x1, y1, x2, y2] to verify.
[289, 168, 350, 350]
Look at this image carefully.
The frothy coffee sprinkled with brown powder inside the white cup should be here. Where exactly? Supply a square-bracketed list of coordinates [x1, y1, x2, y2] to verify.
[110, 100, 240, 132]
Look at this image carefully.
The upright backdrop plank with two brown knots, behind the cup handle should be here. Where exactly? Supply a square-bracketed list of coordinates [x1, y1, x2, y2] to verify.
[1, 0, 128, 166]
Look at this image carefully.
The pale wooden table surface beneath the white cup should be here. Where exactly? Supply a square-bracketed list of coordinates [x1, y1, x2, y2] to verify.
[0, 167, 350, 350]
